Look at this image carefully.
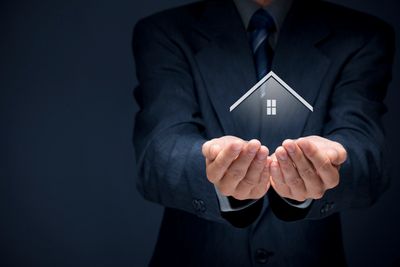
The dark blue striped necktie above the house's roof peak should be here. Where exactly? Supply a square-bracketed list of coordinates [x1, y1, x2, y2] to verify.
[248, 9, 275, 80]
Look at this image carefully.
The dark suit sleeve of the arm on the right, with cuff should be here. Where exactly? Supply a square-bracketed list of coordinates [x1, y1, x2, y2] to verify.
[270, 25, 394, 221]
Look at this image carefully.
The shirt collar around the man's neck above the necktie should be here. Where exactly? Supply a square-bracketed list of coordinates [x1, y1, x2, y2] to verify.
[233, 0, 293, 32]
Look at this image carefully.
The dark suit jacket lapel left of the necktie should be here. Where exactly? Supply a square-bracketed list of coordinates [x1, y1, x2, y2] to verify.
[195, 1, 257, 135]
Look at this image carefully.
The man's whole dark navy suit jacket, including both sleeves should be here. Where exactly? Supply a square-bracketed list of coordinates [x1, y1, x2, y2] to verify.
[133, 0, 394, 266]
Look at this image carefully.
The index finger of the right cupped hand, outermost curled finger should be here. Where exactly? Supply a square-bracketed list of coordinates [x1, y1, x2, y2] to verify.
[297, 138, 339, 188]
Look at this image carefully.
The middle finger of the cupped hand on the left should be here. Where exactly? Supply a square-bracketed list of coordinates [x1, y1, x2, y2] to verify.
[219, 140, 261, 193]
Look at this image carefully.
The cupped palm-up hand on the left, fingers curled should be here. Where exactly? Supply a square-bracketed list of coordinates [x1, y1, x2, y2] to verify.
[202, 136, 272, 200]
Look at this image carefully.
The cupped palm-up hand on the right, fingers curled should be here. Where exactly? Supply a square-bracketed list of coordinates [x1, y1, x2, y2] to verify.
[270, 136, 347, 201]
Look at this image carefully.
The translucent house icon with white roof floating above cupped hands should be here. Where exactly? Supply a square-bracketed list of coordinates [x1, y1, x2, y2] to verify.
[229, 71, 314, 147]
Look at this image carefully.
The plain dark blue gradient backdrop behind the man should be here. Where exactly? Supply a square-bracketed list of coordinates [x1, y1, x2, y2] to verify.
[0, 0, 400, 266]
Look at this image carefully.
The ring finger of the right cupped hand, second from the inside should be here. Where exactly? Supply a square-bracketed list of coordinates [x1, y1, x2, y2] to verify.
[275, 147, 307, 199]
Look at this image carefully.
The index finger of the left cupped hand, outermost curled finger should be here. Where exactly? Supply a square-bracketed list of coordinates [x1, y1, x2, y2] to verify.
[206, 141, 244, 183]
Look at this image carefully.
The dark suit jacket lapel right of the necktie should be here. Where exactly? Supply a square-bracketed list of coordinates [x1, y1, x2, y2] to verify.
[272, 0, 330, 138]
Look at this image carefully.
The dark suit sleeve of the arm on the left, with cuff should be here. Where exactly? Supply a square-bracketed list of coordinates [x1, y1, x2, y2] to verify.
[132, 18, 262, 227]
